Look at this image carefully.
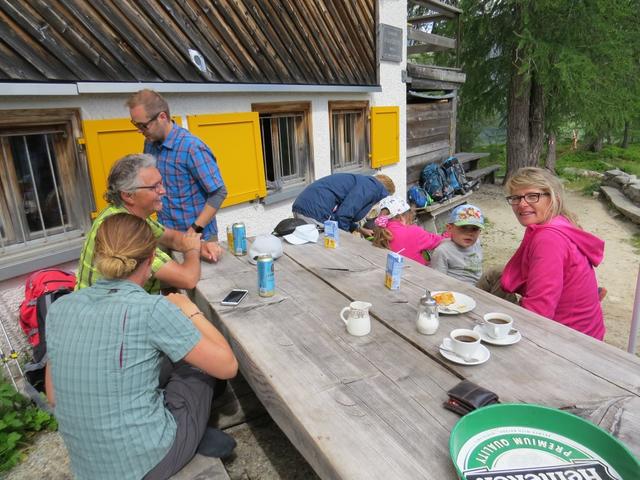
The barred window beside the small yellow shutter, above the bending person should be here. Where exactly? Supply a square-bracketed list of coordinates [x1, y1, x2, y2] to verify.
[329, 101, 369, 172]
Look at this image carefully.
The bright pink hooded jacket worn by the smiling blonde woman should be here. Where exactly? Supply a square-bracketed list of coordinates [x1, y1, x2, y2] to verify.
[502, 215, 605, 340]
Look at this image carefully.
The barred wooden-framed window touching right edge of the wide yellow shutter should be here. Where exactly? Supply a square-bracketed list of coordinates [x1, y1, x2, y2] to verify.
[251, 102, 311, 192]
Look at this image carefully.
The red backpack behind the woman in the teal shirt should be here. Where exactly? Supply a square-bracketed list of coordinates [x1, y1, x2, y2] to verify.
[20, 268, 76, 347]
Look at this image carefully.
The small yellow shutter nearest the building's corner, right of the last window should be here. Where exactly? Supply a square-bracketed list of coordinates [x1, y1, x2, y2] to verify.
[370, 107, 400, 168]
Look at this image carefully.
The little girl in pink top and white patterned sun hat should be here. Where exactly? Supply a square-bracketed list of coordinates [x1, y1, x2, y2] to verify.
[373, 196, 444, 265]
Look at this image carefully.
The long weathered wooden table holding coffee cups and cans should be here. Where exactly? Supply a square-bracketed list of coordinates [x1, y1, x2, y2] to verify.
[195, 232, 640, 479]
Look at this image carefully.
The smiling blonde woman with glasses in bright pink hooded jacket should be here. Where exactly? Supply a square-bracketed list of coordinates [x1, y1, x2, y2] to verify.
[501, 167, 605, 340]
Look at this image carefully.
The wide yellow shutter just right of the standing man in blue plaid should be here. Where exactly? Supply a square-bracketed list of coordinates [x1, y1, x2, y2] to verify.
[187, 112, 267, 207]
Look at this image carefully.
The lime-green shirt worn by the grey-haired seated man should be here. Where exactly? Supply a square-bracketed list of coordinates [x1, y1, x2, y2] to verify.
[76, 205, 171, 293]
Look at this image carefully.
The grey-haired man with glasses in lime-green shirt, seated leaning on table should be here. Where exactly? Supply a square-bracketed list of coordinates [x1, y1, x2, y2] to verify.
[76, 154, 222, 293]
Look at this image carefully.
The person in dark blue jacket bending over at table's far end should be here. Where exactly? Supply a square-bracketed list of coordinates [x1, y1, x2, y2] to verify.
[291, 173, 396, 235]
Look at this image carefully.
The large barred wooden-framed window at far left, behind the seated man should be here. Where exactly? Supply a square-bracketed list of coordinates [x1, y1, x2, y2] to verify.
[0, 109, 92, 253]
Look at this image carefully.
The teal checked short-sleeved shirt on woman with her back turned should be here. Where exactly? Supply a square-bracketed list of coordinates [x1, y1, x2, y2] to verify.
[46, 280, 201, 479]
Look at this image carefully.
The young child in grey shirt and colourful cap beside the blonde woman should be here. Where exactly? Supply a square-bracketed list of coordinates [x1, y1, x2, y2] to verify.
[431, 204, 484, 285]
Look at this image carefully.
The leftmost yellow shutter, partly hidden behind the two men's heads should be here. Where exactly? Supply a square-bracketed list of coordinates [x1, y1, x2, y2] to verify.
[82, 116, 182, 216]
